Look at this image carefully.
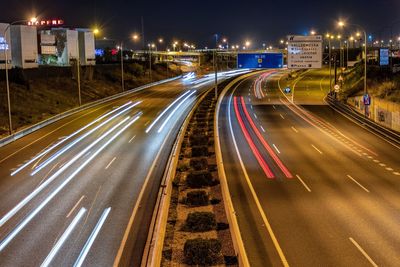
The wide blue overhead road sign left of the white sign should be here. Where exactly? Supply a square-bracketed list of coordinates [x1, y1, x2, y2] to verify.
[237, 53, 283, 69]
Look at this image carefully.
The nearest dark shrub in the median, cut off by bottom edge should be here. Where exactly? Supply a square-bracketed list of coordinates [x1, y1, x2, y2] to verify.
[183, 238, 222, 265]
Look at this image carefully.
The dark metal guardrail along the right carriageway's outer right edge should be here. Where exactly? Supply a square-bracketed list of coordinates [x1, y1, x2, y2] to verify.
[326, 95, 400, 148]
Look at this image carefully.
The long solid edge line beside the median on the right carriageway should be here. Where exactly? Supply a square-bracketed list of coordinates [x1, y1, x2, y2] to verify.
[228, 92, 289, 267]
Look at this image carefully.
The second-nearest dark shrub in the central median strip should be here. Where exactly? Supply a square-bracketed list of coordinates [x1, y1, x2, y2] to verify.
[182, 212, 217, 232]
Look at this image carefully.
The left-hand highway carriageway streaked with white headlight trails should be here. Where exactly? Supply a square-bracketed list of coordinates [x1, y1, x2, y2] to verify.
[0, 71, 247, 266]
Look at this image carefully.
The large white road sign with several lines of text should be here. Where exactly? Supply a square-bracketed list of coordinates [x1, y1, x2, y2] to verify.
[288, 35, 323, 69]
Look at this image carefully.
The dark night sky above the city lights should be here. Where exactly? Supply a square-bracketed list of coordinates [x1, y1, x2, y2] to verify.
[0, 0, 400, 47]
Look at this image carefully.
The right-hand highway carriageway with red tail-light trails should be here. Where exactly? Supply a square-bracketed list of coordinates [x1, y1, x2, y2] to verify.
[218, 70, 400, 266]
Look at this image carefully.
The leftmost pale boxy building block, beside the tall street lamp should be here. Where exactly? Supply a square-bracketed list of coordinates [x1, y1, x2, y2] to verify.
[11, 25, 38, 69]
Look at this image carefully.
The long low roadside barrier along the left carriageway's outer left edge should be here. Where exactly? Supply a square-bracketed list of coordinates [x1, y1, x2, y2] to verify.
[0, 75, 182, 147]
